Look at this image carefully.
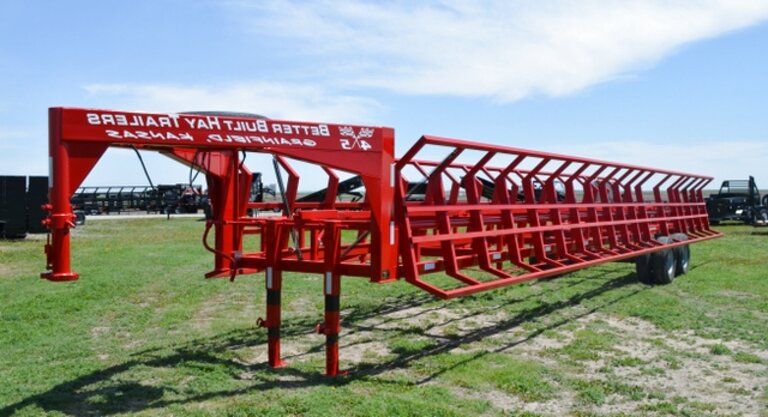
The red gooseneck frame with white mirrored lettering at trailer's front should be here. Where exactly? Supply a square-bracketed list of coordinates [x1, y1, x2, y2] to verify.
[42, 107, 397, 281]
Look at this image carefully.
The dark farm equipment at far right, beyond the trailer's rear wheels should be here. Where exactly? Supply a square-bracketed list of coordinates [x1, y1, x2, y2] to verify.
[706, 176, 768, 224]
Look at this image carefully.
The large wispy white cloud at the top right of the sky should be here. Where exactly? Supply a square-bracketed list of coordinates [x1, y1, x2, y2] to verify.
[229, 0, 768, 102]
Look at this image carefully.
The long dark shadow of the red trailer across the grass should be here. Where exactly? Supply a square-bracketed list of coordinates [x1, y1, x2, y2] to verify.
[0, 266, 647, 417]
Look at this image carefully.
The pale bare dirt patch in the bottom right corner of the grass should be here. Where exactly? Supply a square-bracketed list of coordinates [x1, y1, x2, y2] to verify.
[496, 314, 768, 416]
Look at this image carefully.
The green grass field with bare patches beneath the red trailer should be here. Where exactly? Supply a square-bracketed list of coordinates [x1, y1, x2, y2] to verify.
[0, 219, 768, 417]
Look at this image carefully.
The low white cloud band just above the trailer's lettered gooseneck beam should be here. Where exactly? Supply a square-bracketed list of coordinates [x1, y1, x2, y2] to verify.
[84, 82, 380, 123]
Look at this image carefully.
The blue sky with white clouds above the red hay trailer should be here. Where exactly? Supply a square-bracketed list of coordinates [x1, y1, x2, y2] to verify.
[0, 0, 768, 188]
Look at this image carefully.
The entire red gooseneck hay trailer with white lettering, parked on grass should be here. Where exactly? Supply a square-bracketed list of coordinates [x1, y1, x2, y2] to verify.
[42, 108, 719, 375]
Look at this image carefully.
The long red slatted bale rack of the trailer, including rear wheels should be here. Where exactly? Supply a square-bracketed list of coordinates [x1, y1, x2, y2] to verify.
[395, 136, 719, 298]
